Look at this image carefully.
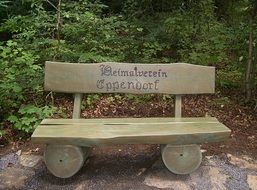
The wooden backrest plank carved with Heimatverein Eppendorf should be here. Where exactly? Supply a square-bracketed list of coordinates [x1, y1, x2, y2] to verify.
[45, 62, 215, 94]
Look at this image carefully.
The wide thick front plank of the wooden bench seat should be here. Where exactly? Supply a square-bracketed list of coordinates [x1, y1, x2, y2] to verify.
[32, 122, 230, 146]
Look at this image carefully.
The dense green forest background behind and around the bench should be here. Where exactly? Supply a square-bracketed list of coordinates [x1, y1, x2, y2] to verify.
[0, 0, 257, 143]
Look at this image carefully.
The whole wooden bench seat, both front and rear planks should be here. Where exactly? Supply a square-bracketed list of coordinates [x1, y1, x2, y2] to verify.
[32, 117, 231, 146]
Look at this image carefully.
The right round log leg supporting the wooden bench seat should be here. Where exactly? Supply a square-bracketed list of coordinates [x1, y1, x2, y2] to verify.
[161, 144, 202, 174]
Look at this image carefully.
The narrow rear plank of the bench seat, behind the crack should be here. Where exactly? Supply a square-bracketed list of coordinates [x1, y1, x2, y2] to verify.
[41, 117, 219, 125]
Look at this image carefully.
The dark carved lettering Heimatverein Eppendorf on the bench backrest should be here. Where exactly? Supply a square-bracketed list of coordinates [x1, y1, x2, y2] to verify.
[96, 64, 168, 92]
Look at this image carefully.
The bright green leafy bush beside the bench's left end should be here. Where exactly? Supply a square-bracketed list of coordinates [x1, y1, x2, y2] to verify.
[0, 40, 53, 132]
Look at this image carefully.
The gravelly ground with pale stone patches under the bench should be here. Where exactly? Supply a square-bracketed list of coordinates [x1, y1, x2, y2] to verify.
[0, 145, 257, 190]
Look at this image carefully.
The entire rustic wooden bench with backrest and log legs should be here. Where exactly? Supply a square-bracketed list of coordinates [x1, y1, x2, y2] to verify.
[32, 62, 231, 178]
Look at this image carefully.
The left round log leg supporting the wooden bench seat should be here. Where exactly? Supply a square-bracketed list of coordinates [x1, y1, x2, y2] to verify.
[44, 145, 91, 178]
